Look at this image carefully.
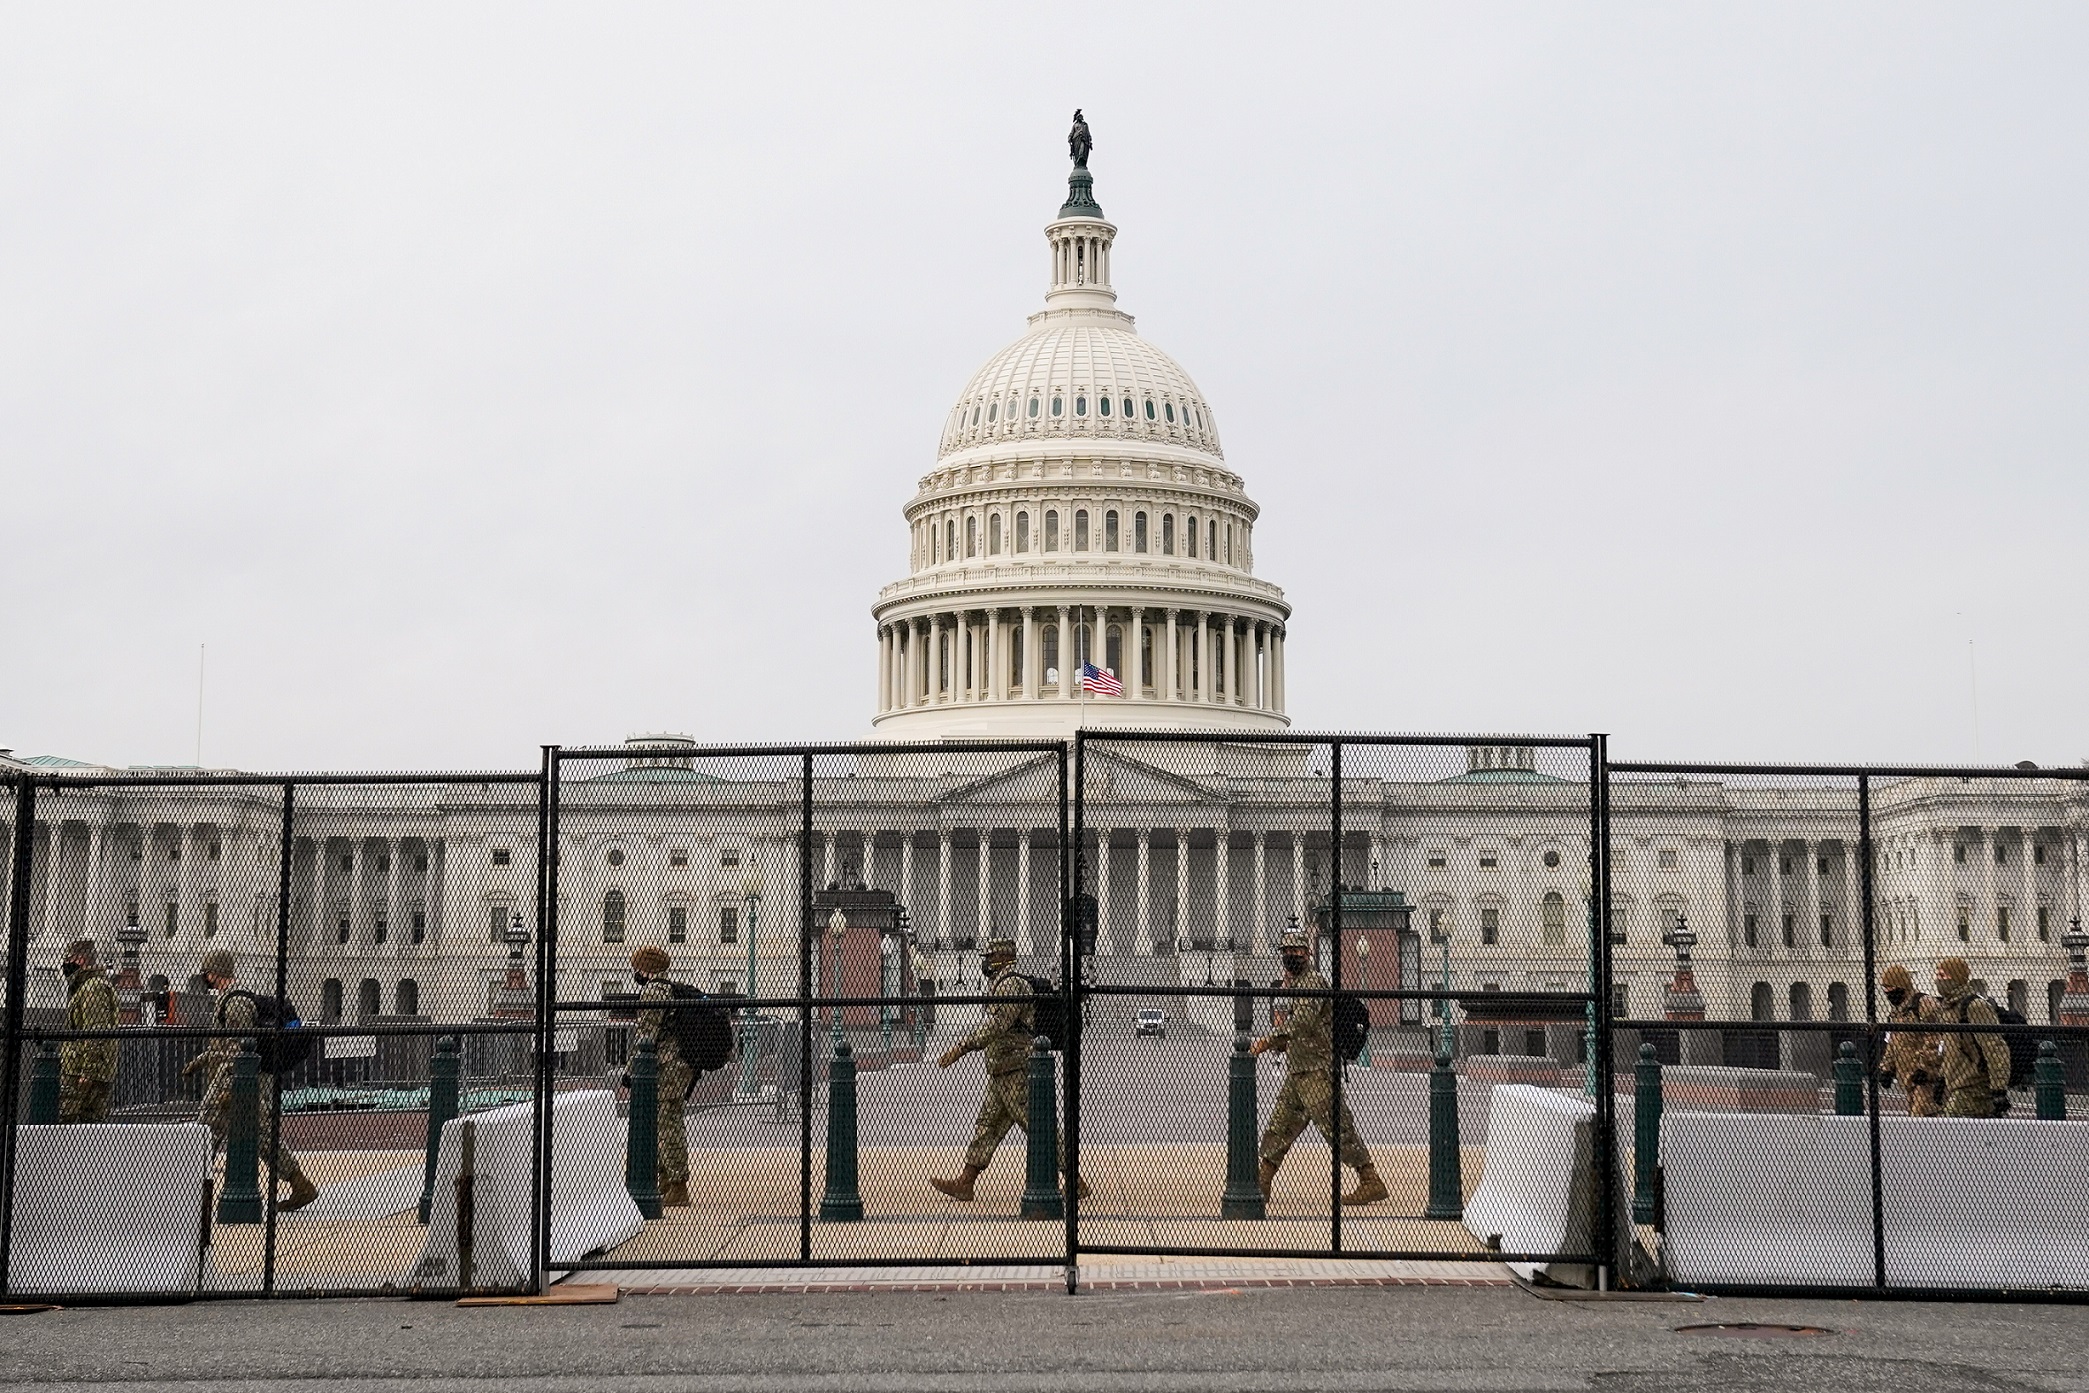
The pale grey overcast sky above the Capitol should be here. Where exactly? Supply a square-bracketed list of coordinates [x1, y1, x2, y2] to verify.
[0, 0, 2089, 769]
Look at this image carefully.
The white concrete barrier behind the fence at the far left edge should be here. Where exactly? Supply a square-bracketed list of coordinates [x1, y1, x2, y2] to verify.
[8, 1122, 216, 1295]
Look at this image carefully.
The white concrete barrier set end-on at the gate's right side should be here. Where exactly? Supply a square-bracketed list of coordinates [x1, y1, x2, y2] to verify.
[1464, 1084, 1638, 1286]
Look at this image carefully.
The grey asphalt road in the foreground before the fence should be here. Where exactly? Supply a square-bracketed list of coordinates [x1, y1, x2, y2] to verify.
[0, 1286, 2089, 1393]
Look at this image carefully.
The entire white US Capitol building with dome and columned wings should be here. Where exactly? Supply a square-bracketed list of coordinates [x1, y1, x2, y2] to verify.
[0, 125, 2089, 1063]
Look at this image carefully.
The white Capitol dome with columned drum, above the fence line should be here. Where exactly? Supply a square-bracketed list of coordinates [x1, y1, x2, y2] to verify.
[873, 143, 1291, 739]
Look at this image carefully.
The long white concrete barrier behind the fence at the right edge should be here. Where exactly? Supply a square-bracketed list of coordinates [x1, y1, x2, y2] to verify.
[1661, 1113, 2089, 1291]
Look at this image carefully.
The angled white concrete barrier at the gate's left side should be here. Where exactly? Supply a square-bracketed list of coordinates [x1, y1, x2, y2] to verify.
[407, 1090, 646, 1286]
